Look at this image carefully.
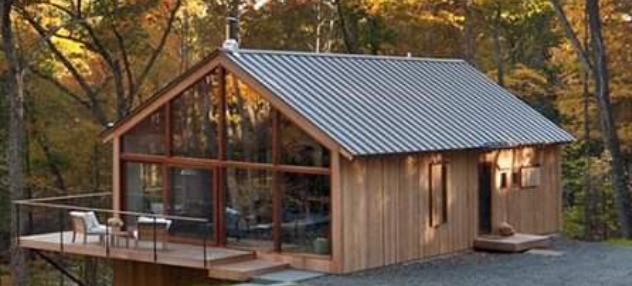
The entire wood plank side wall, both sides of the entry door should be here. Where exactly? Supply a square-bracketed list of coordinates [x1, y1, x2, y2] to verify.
[334, 146, 561, 273]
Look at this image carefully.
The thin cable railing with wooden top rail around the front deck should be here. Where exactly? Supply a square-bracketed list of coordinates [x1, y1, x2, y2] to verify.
[14, 192, 213, 269]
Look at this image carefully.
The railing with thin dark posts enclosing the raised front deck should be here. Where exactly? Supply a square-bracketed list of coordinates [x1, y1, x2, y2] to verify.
[13, 192, 212, 269]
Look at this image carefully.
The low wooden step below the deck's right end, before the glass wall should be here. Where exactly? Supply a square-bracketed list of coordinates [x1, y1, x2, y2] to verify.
[208, 258, 289, 282]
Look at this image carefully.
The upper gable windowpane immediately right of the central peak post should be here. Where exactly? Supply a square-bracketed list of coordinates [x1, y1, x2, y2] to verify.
[226, 74, 272, 163]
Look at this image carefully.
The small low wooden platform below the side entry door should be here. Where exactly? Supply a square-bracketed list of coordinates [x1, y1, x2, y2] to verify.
[474, 233, 551, 252]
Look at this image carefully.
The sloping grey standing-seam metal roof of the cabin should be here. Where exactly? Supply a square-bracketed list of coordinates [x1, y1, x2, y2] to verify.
[223, 50, 573, 155]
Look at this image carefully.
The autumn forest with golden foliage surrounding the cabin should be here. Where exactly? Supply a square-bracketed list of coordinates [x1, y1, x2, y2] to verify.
[0, 0, 632, 286]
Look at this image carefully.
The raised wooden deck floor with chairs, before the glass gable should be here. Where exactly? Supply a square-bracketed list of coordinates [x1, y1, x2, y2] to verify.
[20, 232, 255, 269]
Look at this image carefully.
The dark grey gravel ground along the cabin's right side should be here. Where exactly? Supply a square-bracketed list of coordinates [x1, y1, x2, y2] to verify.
[304, 240, 632, 286]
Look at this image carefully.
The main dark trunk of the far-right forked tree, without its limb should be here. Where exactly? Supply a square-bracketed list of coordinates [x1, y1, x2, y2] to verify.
[586, 0, 632, 238]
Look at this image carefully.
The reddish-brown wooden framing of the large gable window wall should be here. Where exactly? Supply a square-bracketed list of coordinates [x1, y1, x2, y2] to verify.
[117, 66, 334, 255]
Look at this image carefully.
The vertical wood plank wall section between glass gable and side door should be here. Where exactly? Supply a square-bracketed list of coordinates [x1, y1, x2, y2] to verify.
[340, 152, 479, 273]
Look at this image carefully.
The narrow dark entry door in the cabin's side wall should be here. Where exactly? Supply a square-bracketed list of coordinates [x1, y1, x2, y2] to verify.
[478, 163, 492, 234]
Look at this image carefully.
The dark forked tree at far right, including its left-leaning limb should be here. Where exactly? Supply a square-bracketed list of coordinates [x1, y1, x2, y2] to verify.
[550, 0, 632, 238]
